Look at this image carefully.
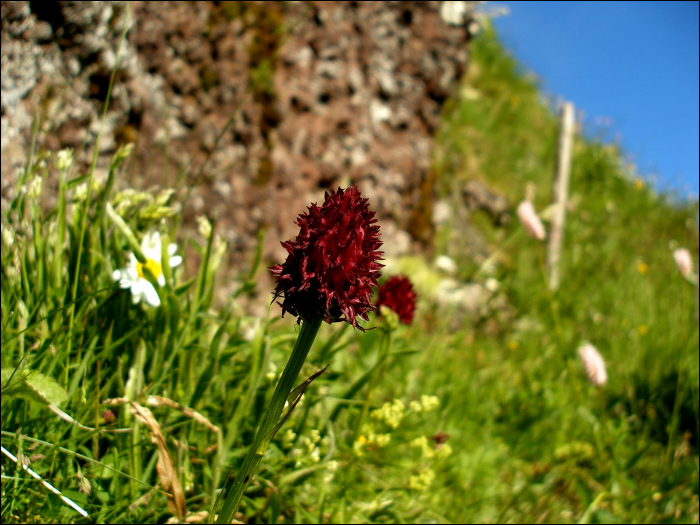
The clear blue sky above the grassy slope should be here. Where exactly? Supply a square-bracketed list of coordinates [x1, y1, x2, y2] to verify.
[486, 2, 700, 197]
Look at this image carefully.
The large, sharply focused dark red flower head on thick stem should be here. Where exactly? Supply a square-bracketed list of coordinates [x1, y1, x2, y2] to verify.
[270, 186, 384, 330]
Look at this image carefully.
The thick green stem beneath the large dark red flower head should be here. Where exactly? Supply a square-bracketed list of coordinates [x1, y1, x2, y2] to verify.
[216, 316, 323, 523]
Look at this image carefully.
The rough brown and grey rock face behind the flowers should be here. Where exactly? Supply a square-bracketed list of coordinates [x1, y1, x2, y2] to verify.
[2, 2, 470, 274]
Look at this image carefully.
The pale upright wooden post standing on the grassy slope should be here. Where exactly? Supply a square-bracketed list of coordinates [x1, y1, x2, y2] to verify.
[547, 102, 576, 291]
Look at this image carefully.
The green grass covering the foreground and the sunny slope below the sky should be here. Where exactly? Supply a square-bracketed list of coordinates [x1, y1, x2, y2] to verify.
[2, 22, 698, 523]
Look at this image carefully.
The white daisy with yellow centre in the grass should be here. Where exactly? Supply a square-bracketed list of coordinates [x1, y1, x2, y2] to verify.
[112, 232, 182, 307]
